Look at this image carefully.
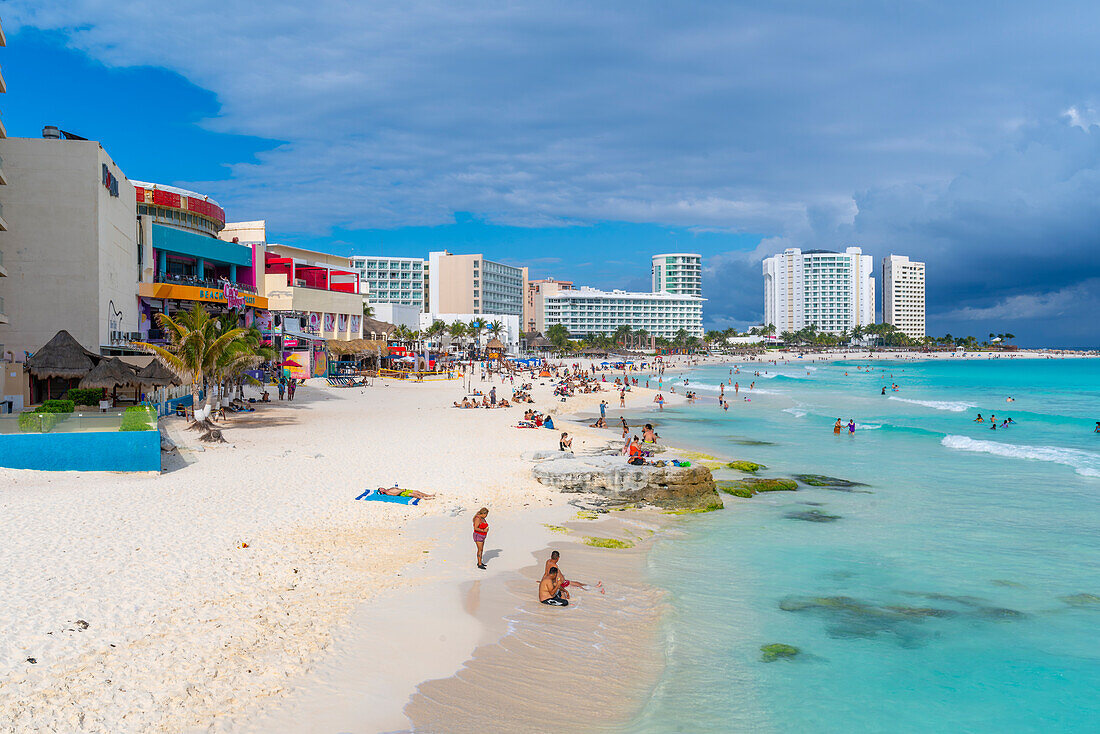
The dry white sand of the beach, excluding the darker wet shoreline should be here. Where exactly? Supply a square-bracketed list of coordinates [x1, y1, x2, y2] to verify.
[0, 367, 652, 732]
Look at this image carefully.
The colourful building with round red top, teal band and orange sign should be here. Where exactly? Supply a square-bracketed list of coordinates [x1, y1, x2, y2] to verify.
[133, 180, 267, 343]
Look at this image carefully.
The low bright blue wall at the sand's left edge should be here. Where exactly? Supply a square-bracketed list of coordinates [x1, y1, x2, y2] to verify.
[0, 430, 161, 471]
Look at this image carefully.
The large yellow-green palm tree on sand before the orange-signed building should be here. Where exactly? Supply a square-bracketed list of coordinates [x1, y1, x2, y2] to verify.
[133, 302, 248, 424]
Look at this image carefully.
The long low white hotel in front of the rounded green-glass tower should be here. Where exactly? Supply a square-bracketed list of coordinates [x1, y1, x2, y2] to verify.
[543, 287, 705, 339]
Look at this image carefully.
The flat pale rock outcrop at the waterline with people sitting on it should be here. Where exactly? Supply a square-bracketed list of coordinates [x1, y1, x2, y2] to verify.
[525, 451, 722, 510]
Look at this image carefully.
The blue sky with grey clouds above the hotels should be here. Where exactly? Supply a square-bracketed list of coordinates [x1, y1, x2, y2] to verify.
[0, 0, 1100, 348]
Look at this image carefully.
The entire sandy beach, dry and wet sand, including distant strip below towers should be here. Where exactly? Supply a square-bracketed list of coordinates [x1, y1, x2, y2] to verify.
[0, 352, 1091, 732]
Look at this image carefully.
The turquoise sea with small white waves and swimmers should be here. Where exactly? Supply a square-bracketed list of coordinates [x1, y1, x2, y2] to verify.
[629, 359, 1100, 733]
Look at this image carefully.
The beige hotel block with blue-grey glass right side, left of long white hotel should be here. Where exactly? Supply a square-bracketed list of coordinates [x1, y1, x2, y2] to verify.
[428, 250, 527, 318]
